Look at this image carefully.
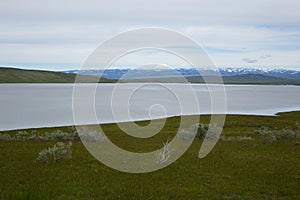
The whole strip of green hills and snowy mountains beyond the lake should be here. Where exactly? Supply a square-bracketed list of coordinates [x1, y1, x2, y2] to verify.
[0, 67, 300, 85]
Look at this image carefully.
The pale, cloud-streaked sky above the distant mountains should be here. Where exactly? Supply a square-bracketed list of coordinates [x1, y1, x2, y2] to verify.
[0, 0, 300, 71]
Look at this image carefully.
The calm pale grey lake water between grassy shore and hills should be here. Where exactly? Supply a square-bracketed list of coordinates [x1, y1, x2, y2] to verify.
[0, 83, 300, 130]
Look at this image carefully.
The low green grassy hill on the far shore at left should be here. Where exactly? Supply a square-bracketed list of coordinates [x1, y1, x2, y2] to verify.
[0, 68, 112, 83]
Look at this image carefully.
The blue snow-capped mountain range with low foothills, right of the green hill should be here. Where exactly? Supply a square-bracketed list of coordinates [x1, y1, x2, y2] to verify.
[66, 68, 300, 85]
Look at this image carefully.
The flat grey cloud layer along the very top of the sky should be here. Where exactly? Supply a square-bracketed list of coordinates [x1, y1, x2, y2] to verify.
[0, 0, 300, 26]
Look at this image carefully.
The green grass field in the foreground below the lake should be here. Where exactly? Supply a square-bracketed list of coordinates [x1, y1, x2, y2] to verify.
[0, 112, 300, 199]
